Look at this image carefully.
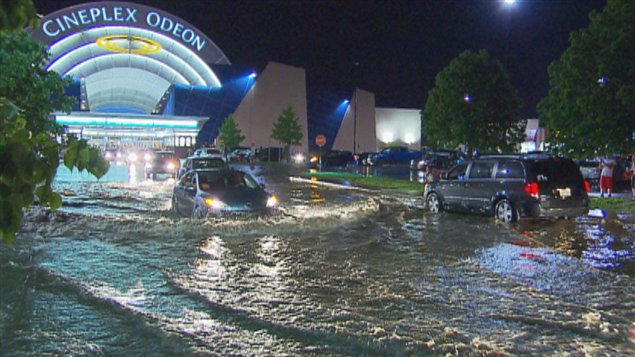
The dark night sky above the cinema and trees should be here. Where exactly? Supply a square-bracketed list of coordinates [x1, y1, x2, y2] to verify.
[34, 0, 606, 117]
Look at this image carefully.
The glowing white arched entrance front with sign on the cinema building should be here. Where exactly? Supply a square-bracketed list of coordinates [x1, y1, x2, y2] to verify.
[32, 2, 230, 146]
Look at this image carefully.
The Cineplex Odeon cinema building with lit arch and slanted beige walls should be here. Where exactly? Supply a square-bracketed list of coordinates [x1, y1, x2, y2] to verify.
[32, 2, 421, 156]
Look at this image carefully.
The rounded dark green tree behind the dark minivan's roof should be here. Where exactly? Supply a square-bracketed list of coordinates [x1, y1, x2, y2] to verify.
[422, 50, 524, 151]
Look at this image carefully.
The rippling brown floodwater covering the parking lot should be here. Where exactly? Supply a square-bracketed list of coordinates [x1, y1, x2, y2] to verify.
[0, 163, 635, 356]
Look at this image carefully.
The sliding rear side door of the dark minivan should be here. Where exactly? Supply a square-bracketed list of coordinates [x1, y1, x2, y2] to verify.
[463, 159, 496, 214]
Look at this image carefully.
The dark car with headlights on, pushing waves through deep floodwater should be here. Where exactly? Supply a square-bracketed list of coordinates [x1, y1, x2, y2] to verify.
[172, 169, 278, 219]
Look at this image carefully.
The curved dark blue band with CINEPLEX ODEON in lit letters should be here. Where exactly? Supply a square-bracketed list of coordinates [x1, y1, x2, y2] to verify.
[40, 2, 206, 52]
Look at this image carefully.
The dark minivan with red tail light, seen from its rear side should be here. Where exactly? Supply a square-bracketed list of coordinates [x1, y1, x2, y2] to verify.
[424, 154, 590, 223]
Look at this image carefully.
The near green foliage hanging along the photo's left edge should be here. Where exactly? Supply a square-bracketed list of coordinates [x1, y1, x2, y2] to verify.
[0, 0, 109, 242]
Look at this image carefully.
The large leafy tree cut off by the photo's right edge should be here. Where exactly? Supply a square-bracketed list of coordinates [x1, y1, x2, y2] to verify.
[538, 0, 635, 156]
